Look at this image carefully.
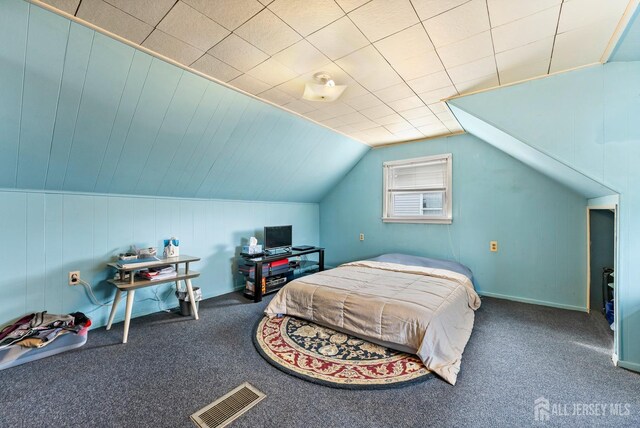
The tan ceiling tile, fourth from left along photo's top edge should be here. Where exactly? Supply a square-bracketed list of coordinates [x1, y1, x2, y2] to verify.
[181, 0, 264, 31]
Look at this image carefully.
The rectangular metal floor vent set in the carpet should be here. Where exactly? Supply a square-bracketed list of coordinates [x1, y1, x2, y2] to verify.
[191, 382, 266, 428]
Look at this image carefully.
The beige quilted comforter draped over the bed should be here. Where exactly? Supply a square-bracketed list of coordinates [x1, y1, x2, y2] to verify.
[265, 261, 480, 385]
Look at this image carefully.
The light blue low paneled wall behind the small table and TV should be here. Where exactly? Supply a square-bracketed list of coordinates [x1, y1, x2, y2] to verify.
[0, 191, 319, 326]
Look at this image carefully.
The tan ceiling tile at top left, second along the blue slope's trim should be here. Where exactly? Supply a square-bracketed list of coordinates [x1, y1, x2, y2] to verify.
[76, 0, 153, 44]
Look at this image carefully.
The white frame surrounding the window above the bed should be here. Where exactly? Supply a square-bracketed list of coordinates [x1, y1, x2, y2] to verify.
[382, 153, 453, 224]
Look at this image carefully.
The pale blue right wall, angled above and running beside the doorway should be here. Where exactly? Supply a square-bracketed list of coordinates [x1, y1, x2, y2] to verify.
[454, 62, 640, 370]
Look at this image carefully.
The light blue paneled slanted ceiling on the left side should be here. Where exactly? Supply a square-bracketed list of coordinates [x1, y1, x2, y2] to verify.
[0, 0, 368, 201]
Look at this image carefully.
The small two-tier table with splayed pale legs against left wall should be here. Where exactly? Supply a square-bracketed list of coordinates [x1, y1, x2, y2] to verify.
[107, 256, 200, 343]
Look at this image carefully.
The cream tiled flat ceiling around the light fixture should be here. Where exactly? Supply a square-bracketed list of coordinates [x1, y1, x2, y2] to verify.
[33, 0, 635, 145]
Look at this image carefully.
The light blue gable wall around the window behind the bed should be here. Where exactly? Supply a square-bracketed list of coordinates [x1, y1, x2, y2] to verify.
[320, 134, 587, 310]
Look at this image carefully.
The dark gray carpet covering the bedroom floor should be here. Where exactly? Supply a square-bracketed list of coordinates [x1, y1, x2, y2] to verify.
[0, 294, 640, 428]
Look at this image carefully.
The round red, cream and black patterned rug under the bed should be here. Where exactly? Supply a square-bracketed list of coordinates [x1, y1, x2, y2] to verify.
[253, 316, 432, 389]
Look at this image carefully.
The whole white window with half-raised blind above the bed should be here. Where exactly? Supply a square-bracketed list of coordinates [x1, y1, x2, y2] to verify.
[382, 153, 451, 223]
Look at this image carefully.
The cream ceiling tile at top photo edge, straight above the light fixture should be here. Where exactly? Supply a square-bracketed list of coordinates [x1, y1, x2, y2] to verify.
[269, 0, 344, 37]
